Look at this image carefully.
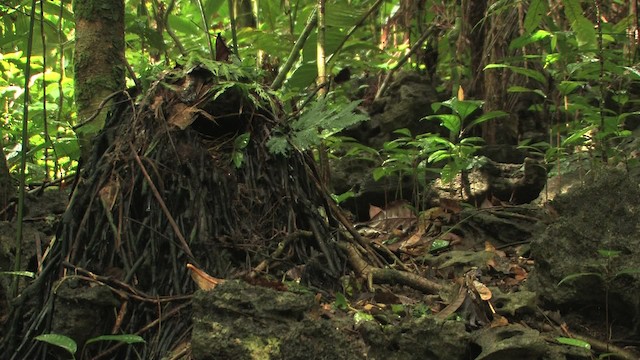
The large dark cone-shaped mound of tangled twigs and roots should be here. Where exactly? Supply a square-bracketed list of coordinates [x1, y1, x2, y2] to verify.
[0, 66, 345, 359]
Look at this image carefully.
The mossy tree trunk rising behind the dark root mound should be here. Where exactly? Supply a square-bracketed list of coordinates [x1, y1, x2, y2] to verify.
[73, 0, 125, 159]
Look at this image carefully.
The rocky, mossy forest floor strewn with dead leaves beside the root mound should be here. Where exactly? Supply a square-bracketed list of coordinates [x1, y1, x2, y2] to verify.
[0, 167, 640, 359]
